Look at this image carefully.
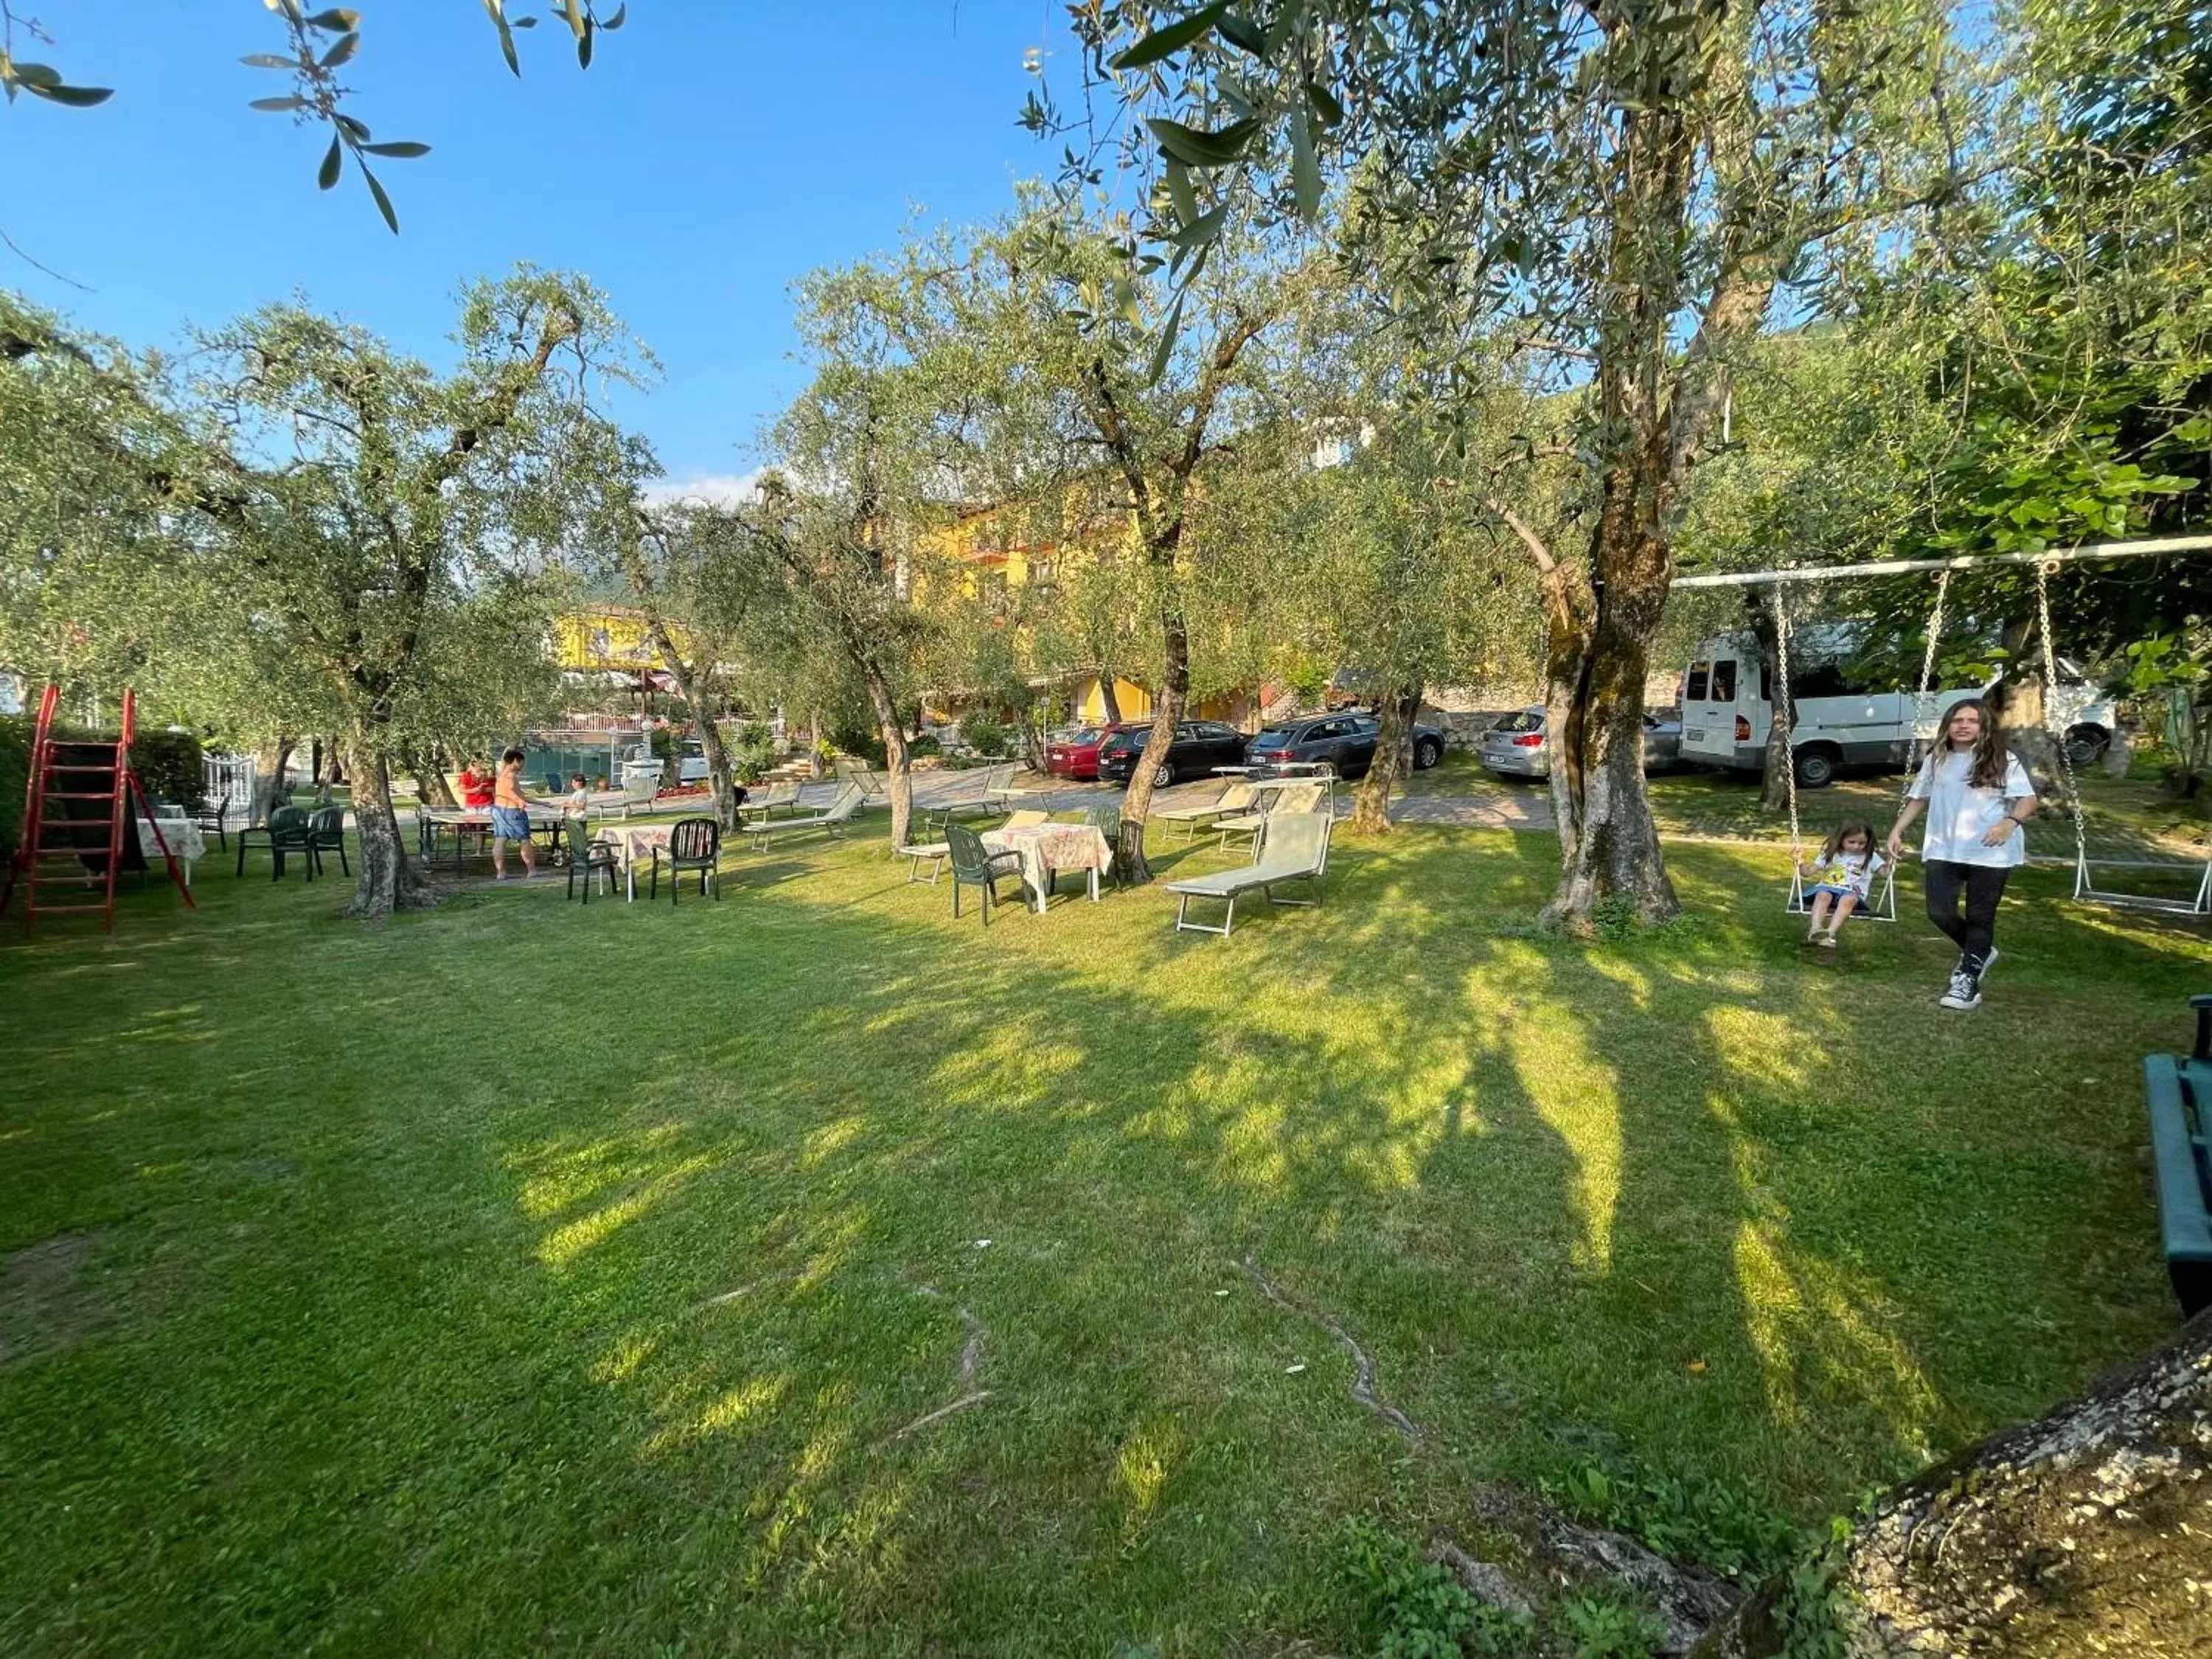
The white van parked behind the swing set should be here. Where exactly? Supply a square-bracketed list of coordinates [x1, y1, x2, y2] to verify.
[1681, 624, 2115, 790]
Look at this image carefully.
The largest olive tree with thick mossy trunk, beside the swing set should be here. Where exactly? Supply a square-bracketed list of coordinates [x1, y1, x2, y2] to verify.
[1071, 0, 1980, 925]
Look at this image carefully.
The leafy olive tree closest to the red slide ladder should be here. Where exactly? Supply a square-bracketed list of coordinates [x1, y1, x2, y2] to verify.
[0, 268, 639, 916]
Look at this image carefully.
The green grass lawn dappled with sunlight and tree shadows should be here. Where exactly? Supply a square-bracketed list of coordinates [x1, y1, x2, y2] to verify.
[0, 814, 2212, 1655]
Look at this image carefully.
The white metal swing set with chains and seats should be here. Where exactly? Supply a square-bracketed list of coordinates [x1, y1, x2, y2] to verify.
[1674, 535, 2212, 922]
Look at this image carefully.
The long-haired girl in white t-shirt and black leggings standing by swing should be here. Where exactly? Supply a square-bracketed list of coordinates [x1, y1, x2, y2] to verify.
[1889, 697, 2035, 1009]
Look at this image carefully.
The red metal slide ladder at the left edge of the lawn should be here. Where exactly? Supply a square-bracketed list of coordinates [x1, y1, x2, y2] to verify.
[0, 686, 199, 933]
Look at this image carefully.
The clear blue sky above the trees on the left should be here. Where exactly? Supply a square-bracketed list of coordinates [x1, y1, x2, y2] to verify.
[0, 0, 1073, 482]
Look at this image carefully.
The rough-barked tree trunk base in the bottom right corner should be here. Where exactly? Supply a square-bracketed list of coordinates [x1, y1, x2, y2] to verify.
[1694, 1314, 2212, 1659]
